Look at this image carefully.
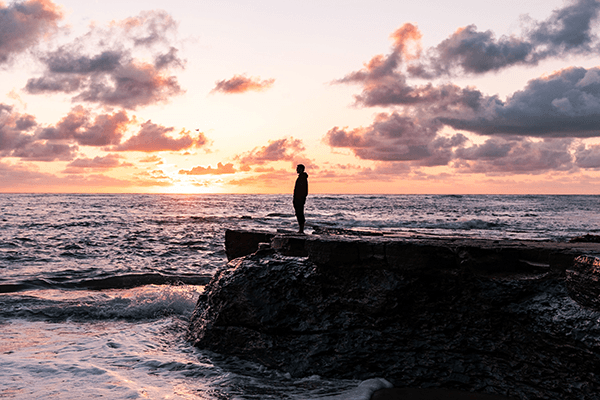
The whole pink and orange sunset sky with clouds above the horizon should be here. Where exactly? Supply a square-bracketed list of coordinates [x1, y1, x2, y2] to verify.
[0, 0, 600, 194]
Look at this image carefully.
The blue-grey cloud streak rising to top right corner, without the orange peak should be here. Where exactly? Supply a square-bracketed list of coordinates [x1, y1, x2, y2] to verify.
[408, 0, 600, 78]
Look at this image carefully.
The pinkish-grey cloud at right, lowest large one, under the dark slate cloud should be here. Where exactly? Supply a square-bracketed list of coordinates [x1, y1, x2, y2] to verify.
[324, 113, 580, 174]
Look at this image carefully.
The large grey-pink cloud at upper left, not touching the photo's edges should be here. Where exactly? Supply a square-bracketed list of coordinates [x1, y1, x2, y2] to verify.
[25, 11, 184, 110]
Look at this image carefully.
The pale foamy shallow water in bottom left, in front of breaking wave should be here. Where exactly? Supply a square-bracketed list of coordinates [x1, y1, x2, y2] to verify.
[0, 320, 219, 400]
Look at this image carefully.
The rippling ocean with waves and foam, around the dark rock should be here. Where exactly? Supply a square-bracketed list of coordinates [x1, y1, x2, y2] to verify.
[0, 194, 600, 400]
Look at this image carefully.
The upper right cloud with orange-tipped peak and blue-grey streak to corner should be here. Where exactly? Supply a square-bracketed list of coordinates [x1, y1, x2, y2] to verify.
[336, 0, 600, 107]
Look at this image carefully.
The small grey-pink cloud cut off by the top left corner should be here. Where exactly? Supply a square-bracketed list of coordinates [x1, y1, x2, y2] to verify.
[0, 0, 63, 64]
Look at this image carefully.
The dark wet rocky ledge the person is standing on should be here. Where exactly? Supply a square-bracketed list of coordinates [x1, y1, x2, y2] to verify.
[189, 231, 600, 400]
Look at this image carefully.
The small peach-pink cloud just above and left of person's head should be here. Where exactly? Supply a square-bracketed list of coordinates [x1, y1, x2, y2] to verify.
[236, 138, 304, 171]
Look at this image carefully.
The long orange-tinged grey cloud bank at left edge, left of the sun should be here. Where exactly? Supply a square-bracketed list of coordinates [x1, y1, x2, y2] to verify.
[0, 103, 208, 162]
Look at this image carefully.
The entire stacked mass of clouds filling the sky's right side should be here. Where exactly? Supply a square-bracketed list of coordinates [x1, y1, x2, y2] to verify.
[324, 0, 600, 174]
